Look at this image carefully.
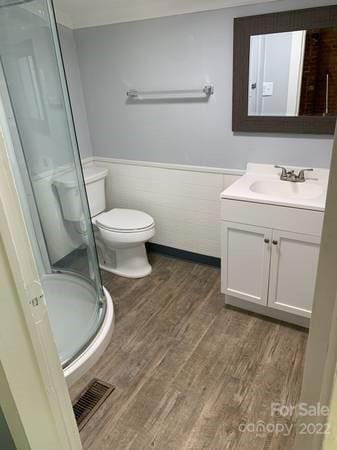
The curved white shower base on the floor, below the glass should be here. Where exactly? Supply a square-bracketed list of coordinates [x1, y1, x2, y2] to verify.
[42, 274, 114, 386]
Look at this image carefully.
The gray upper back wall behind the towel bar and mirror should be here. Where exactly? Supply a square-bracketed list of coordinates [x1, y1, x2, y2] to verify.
[75, 0, 334, 169]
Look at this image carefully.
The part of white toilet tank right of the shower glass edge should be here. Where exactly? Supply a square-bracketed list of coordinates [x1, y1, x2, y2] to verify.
[83, 165, 108, 217]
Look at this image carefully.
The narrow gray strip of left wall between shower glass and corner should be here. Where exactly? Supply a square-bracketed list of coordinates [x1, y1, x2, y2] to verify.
[58, 25, 92, 158]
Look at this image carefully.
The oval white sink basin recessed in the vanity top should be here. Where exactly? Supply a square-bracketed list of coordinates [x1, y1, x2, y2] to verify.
[249, 180, 323, 199]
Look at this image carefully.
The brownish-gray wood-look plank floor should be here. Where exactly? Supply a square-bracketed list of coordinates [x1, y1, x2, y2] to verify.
[71, 254, 307, 450]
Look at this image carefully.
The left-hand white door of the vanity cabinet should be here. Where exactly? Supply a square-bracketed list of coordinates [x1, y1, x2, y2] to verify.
[221, 221, 272, 305]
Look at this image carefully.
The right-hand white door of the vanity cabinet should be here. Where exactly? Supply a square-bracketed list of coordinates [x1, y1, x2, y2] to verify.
[268, 231, 320, 317]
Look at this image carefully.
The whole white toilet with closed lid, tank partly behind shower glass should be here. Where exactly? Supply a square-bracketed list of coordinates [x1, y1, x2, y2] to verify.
[54, 165, 155, 278]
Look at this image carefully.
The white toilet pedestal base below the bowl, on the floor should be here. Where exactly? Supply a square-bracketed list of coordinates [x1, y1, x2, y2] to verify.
[99, 244, 152, 278]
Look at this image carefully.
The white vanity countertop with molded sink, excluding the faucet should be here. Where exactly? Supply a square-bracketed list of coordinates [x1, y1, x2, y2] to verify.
[221, 163, 329, 211]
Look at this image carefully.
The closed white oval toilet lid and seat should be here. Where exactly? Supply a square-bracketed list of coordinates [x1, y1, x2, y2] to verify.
[95, 208, 154, 232]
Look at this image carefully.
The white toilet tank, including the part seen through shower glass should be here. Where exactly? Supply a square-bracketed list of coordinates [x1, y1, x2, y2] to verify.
[53, 165, 108, 222]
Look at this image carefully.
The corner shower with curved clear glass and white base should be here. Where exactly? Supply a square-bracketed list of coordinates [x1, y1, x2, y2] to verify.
[0, 0, 114, 384]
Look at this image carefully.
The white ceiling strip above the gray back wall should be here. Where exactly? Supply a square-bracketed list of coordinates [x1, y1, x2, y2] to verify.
[54, 0, 277, 28]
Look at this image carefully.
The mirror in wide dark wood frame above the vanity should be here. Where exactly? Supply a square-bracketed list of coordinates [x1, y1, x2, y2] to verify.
[232, 5, 337, 134]
